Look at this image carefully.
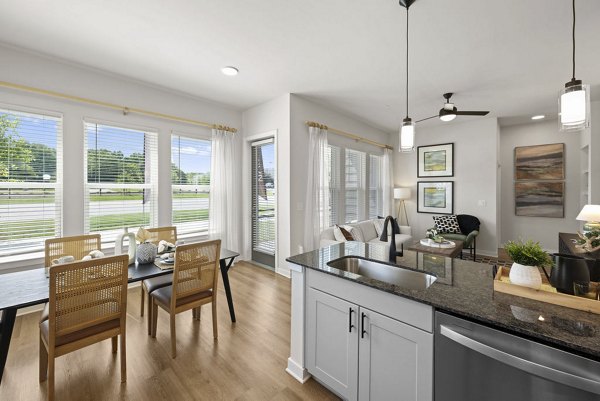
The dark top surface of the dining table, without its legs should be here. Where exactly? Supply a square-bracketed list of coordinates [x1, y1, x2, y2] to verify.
[0, 248, 239, 310]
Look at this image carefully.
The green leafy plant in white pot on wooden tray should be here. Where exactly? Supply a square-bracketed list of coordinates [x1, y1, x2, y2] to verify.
[504, 240, 552, 289]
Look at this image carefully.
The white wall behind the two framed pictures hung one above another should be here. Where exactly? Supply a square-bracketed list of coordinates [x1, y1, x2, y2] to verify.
[393, 118, 498, 256]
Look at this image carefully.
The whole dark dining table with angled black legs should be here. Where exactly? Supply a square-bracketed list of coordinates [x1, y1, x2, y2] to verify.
[0, 248, 240, 383]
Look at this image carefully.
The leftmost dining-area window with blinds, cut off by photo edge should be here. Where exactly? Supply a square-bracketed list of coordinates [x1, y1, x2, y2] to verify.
[0, 109, 62, 256]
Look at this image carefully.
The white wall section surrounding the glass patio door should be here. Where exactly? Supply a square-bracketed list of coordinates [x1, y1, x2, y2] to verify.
[241, 94, 293, 276]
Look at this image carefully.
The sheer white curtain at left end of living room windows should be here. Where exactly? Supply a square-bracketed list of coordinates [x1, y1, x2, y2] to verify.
[304, 127, 330, 251]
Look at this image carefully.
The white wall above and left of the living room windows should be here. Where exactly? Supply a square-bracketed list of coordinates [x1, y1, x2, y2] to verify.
[290, 94, 391, 255]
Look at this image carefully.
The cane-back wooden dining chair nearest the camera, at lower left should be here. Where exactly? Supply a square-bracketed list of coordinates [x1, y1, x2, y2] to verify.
[39, 255, 129, 401]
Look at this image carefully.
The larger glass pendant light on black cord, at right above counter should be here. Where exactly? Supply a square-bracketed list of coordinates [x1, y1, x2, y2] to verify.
[558, 0, 590, 131]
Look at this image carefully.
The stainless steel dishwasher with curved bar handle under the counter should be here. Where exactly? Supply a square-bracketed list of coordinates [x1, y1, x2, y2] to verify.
[434, 312, 600, 401]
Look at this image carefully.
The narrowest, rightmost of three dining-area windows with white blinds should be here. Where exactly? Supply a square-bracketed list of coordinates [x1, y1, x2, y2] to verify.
[171, 135, 211, 236]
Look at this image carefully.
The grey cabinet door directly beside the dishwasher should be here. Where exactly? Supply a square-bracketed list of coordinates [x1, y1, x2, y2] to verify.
[358, 308, 433, 401]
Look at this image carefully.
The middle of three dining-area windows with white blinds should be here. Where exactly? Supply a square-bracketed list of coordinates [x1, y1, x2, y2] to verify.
[85, 122, 158, 242]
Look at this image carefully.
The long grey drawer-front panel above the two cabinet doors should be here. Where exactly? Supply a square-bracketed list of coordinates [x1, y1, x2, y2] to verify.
[306, 269, 433, 333]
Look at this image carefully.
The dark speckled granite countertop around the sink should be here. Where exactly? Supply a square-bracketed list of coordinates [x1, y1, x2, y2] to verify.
[287, 242, 600, 361]
